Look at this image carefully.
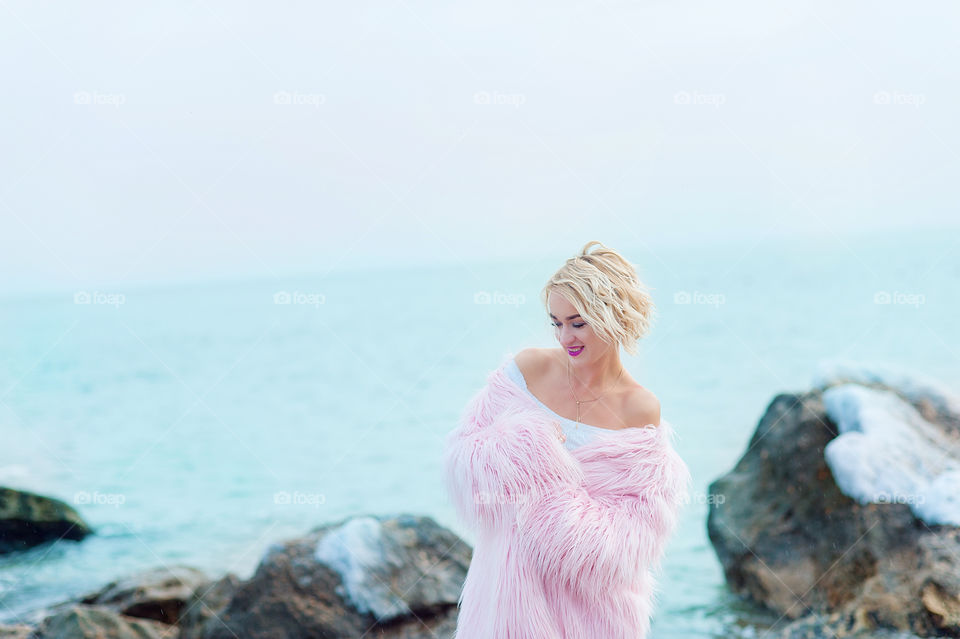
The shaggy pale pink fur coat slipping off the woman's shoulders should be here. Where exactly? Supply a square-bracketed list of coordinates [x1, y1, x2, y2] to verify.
[443, 359, 690, 639]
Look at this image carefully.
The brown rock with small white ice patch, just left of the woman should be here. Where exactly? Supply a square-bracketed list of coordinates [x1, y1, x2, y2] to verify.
[204, 515, 471, 639]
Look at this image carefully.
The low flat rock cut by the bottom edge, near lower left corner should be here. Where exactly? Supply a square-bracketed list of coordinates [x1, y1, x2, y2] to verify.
[38, 605, 178, 639]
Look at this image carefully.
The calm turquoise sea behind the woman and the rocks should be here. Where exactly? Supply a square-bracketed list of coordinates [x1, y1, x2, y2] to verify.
[0, 231, 960, 638]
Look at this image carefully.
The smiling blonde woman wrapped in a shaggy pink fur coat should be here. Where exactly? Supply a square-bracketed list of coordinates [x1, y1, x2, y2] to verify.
[444, 241, 690, 639]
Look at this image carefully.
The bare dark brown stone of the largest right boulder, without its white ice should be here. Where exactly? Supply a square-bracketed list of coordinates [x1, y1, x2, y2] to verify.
[707, 374, 960, 639]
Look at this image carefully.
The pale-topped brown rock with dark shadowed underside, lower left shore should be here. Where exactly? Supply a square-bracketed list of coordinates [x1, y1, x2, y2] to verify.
[81, 566, 210, 624]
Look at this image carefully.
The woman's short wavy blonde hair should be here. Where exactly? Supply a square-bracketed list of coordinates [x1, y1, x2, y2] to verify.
[540, 240, 656, 355]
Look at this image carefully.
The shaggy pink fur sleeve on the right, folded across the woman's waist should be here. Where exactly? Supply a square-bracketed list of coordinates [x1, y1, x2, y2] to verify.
[517, 440, 691, 599]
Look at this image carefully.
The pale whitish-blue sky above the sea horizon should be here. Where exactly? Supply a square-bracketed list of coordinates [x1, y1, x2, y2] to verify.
[0, 0, 960, 293]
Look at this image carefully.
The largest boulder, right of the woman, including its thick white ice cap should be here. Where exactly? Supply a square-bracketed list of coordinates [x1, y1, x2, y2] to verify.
[707, 361, 960, 639]
